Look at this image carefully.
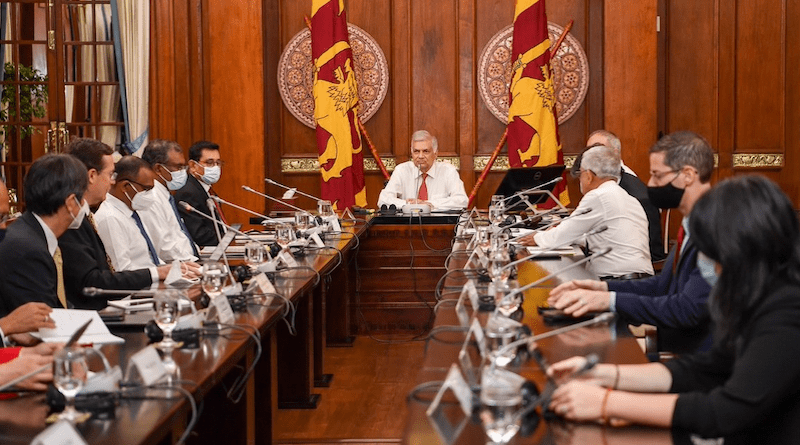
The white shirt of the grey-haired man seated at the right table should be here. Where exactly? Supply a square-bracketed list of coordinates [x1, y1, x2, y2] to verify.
[533, 181, 653, 277]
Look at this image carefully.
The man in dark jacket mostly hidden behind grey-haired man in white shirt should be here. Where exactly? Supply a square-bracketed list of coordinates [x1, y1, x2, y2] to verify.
[573, 130, 667, 261]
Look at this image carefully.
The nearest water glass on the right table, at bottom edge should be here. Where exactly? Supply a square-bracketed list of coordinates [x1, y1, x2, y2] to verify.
[480, 370, 522, 444]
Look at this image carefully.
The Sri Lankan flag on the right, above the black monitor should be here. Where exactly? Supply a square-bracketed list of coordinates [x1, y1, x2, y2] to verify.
[508, 0, 569, 207]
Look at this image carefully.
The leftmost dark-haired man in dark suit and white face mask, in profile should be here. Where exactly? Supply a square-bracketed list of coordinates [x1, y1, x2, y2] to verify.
[0, 155, 89, 317]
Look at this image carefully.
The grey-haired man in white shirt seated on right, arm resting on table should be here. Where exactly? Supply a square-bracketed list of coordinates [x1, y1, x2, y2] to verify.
[523, 146, 653, 279]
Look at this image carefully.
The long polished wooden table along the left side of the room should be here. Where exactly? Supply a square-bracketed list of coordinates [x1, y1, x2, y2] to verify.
[0, 221, 368, 445]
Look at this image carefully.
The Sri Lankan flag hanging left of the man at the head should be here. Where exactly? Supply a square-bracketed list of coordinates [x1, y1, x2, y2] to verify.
[311, 0, 367, 210]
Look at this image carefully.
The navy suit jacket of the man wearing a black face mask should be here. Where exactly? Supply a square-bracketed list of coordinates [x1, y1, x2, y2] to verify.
[608, 238, 712, 353]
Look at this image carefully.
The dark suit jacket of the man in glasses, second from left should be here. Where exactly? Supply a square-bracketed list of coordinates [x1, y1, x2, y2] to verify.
[58, 218, 152, 310]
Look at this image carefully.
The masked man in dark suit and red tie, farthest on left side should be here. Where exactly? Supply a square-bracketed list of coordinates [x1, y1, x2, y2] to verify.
[175, 141, 225, 246]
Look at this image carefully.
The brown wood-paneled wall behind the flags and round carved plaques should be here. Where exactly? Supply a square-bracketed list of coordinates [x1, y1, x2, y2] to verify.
[150, 0, 800, 220]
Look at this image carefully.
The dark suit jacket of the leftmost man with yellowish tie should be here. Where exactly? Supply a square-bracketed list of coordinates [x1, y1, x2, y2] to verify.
[0, 212, 62, 317]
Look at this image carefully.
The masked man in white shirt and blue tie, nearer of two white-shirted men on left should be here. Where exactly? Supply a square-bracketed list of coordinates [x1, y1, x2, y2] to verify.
[94, 156, 164, 272]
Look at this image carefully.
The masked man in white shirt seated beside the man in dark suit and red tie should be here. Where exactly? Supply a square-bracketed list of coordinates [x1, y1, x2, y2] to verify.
[140, 139, 200, 262]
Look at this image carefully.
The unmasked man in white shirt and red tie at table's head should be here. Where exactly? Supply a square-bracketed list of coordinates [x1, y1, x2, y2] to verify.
[378, 130, 469, 210]
